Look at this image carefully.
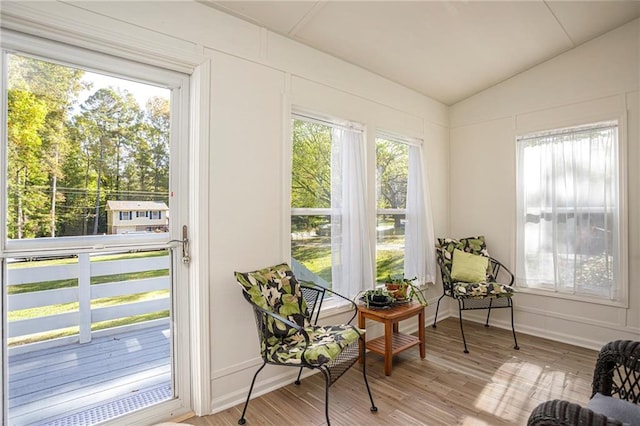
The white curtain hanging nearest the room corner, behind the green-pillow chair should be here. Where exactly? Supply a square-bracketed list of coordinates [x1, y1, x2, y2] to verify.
[404, 145, 436, 283]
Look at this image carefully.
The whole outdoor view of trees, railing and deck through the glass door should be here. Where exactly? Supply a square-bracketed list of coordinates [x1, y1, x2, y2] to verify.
[5, 53, 174, 425]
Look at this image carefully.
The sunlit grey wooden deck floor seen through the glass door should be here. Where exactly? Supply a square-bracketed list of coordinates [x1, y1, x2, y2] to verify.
[8, 325, 172, 426]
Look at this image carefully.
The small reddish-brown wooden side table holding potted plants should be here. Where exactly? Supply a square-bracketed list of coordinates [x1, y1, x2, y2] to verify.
[358, 302, 425, 376]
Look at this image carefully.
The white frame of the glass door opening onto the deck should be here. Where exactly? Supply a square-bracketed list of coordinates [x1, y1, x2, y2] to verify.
[0, 25, 195, 423]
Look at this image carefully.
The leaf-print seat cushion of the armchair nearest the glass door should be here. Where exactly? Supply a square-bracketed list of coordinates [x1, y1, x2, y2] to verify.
[262, 325, 364, 367]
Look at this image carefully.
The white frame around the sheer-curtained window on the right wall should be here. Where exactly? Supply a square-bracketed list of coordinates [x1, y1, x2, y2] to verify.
[513, 118, 629, 308]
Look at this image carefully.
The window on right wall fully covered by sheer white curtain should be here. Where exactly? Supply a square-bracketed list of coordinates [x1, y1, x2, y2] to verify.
[517, 121, 622, 301]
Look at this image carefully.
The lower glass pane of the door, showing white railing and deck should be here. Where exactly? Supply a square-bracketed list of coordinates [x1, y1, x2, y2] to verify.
[6, 249, 173, 425]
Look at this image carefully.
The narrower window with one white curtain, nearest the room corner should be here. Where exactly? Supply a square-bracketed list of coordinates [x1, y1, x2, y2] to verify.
[376, 133, 435, 283]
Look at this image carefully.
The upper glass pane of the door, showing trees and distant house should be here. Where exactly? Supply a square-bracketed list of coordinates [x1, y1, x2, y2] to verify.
[6, 54, 170, 239]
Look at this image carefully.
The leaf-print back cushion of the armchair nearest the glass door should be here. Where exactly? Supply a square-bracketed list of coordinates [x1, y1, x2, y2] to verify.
[235, 263, 310, 338]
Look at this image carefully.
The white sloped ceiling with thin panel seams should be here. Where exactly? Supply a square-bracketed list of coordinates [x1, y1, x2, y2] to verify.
[203, 0, 640, 105]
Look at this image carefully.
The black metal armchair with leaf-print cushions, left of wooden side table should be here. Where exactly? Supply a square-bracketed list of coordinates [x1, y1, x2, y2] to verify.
[235, 263, 378, 425]
